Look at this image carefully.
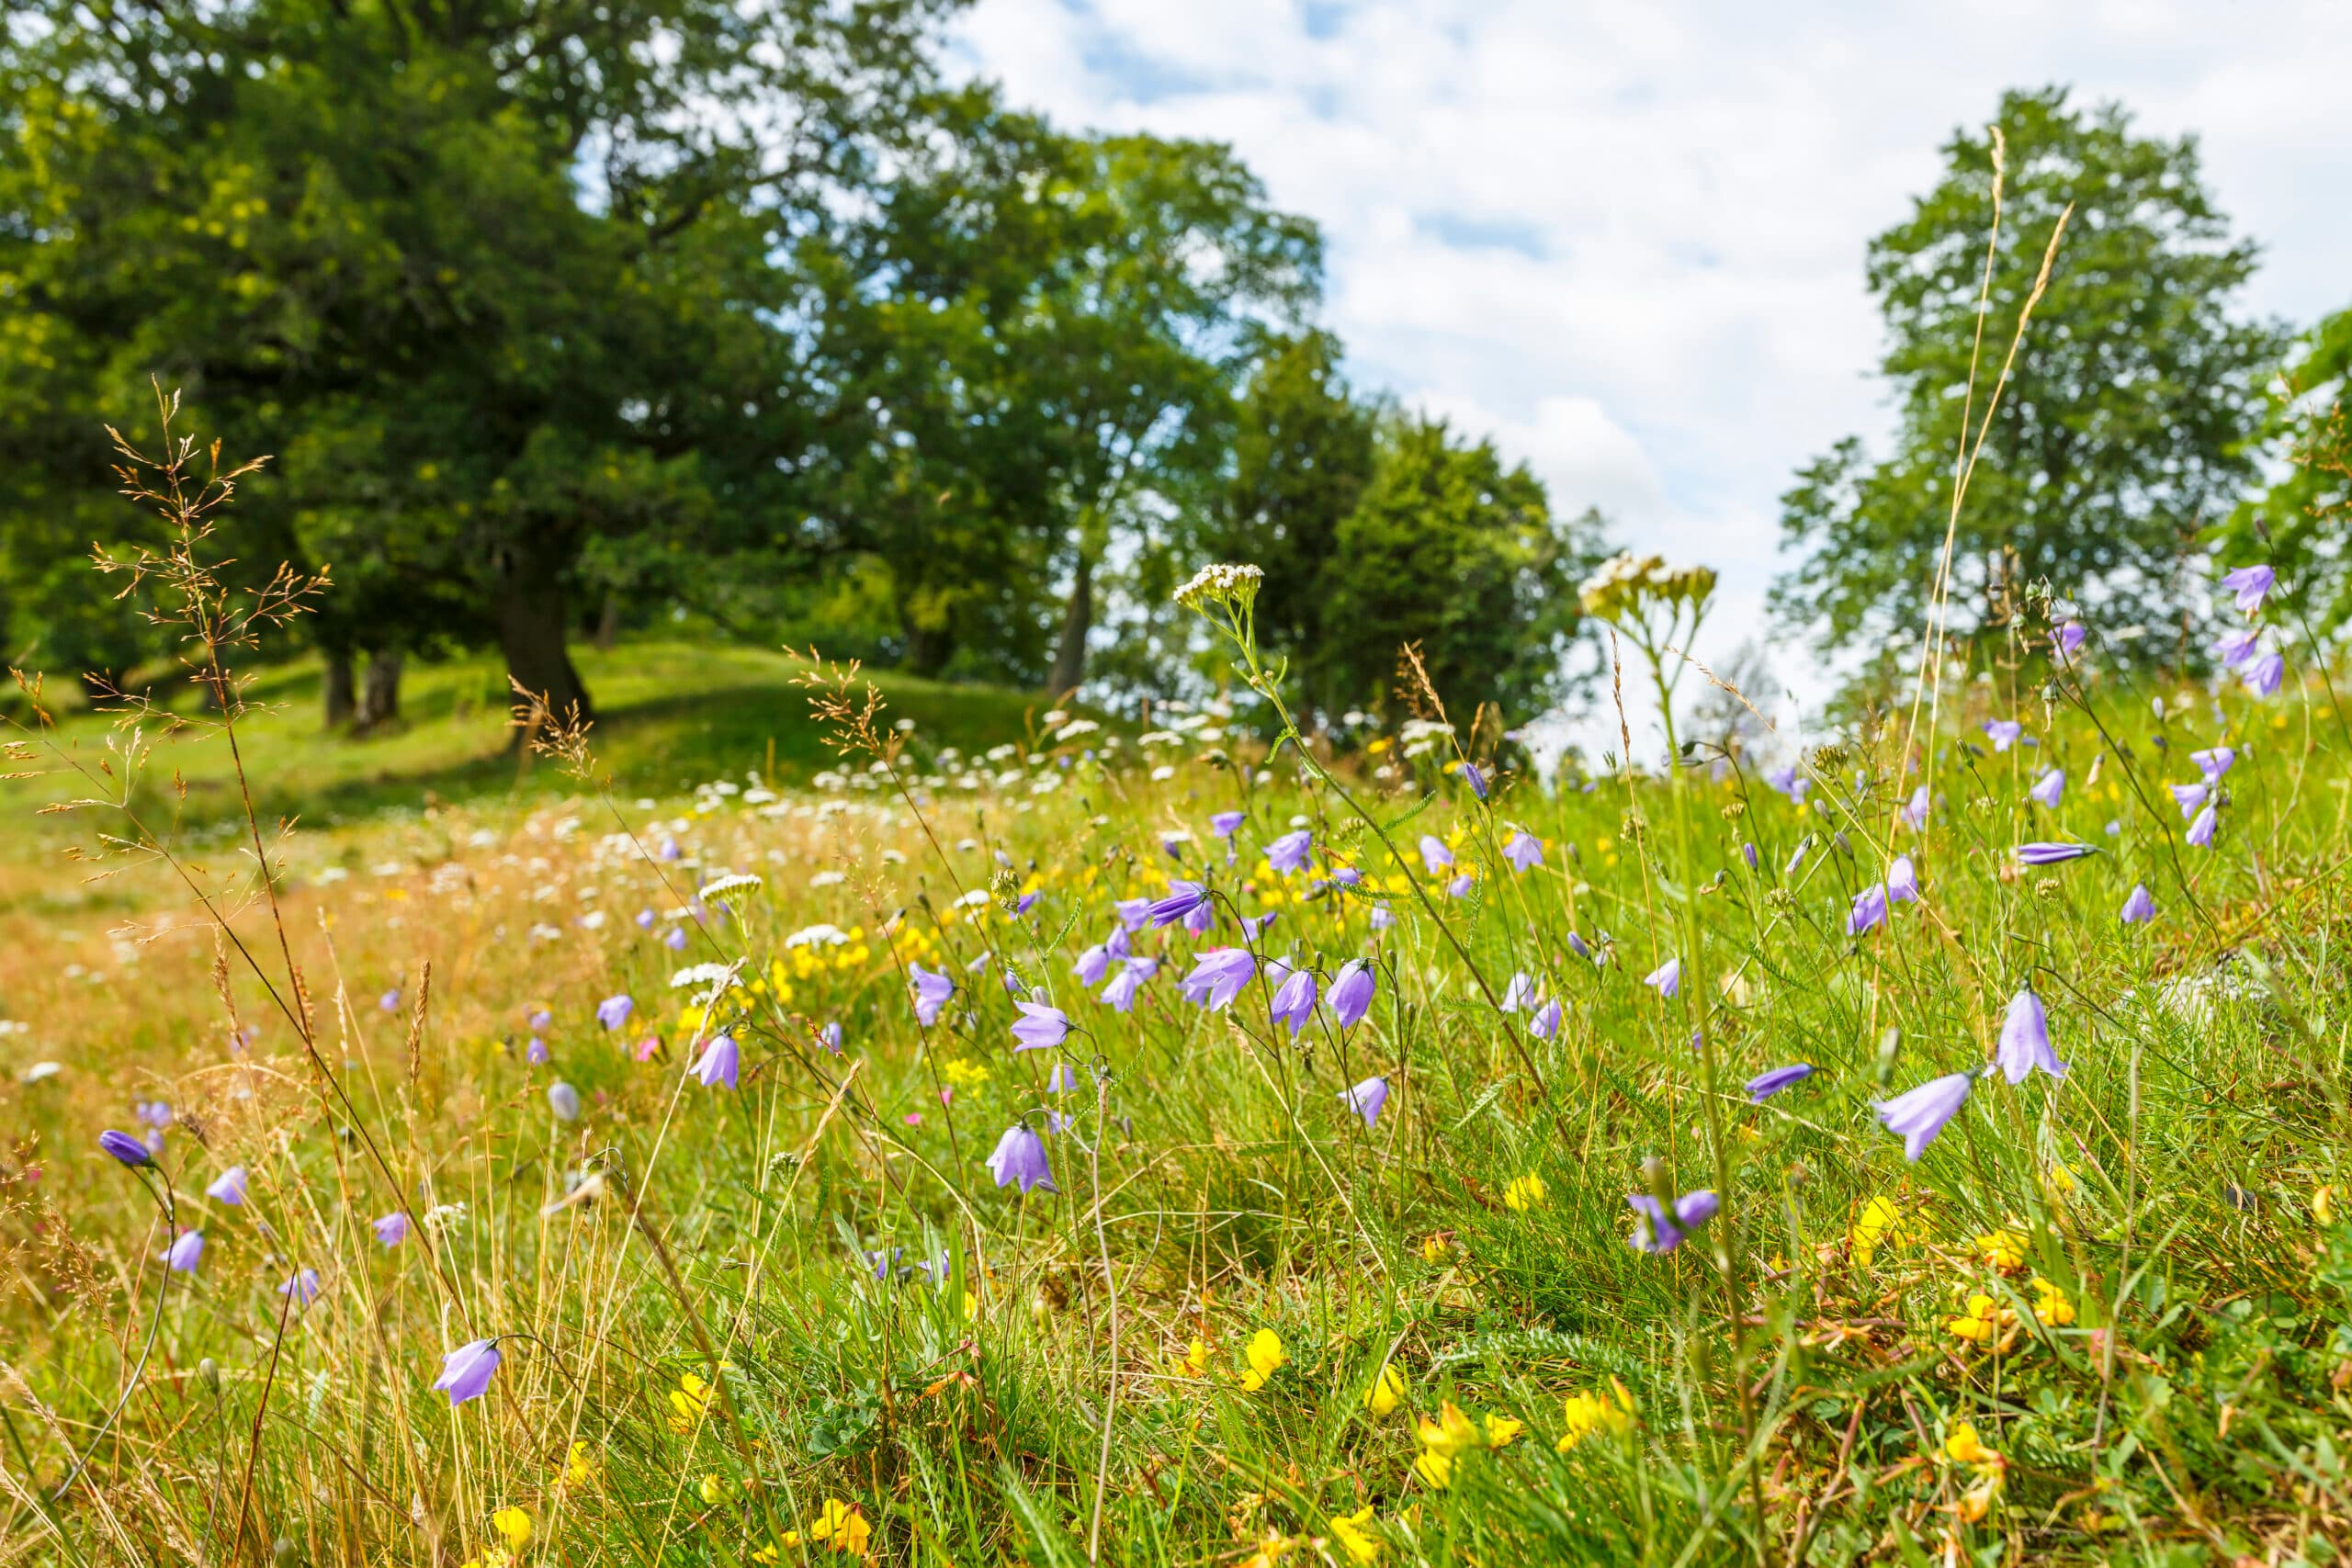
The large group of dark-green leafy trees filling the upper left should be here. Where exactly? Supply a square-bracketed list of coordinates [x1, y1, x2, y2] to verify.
[0, 0, 1600, 722]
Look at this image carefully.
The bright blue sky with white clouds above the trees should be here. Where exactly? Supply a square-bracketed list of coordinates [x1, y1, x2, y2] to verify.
[955, 0, 2352, 761]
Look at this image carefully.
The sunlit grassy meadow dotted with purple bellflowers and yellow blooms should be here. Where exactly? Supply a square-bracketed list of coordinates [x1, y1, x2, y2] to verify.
[0, 531, 2352, 1568]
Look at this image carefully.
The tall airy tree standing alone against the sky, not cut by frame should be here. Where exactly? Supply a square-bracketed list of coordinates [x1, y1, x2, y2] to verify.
[1771, 89, 2281, 659]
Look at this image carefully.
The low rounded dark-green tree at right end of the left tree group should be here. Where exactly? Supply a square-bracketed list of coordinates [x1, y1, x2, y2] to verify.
[1317, 419, 1601, 722]
